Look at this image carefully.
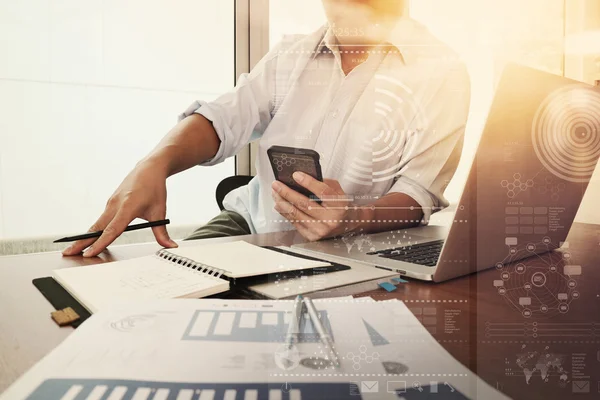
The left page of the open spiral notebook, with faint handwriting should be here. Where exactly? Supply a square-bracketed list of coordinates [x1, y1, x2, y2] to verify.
[53, 255, 229, 312]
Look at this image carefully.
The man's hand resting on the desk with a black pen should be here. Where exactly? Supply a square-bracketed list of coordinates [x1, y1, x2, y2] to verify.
[63, 160, 177, 257]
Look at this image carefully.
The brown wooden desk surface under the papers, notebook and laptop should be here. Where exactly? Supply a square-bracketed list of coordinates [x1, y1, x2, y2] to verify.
[0, 224, 600, 399]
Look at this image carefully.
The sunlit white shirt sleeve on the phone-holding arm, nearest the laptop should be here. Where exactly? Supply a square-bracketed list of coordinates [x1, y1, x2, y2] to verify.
[388, 63, 471, 224]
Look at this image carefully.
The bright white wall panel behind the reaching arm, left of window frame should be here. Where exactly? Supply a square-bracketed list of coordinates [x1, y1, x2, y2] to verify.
[0, 0, 234, 238]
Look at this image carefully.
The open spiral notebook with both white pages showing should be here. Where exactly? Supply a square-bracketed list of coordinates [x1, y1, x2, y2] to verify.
[53, 240, 330, 313]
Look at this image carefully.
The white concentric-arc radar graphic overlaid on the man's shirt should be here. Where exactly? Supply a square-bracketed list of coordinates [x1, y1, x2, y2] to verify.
[347, 74, 429, 186]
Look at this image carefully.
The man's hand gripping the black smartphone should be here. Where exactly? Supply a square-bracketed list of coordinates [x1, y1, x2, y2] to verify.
[272, 172, 369, 241]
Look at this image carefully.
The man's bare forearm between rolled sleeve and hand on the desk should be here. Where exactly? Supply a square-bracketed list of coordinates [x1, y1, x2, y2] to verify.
[140, 114, 221, 177]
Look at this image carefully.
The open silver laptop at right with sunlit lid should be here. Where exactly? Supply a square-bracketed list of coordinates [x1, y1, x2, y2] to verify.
[294, 64, 600, 282]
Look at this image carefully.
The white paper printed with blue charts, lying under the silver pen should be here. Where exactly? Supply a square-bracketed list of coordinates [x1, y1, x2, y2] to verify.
[0, 298, 506, 400]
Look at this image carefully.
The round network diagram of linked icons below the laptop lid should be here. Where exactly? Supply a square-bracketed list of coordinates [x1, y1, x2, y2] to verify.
[493, 237, 582, 318]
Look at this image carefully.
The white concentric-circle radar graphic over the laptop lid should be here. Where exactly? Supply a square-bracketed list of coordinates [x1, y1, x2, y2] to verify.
[532, 85, 600, 183]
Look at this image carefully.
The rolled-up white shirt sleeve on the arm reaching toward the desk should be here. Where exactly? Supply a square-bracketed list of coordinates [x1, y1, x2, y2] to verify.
[179, 46, 280, 165]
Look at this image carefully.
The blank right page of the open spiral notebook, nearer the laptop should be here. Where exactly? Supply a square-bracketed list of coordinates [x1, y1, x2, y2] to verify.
[168, 240, 330, 278]
